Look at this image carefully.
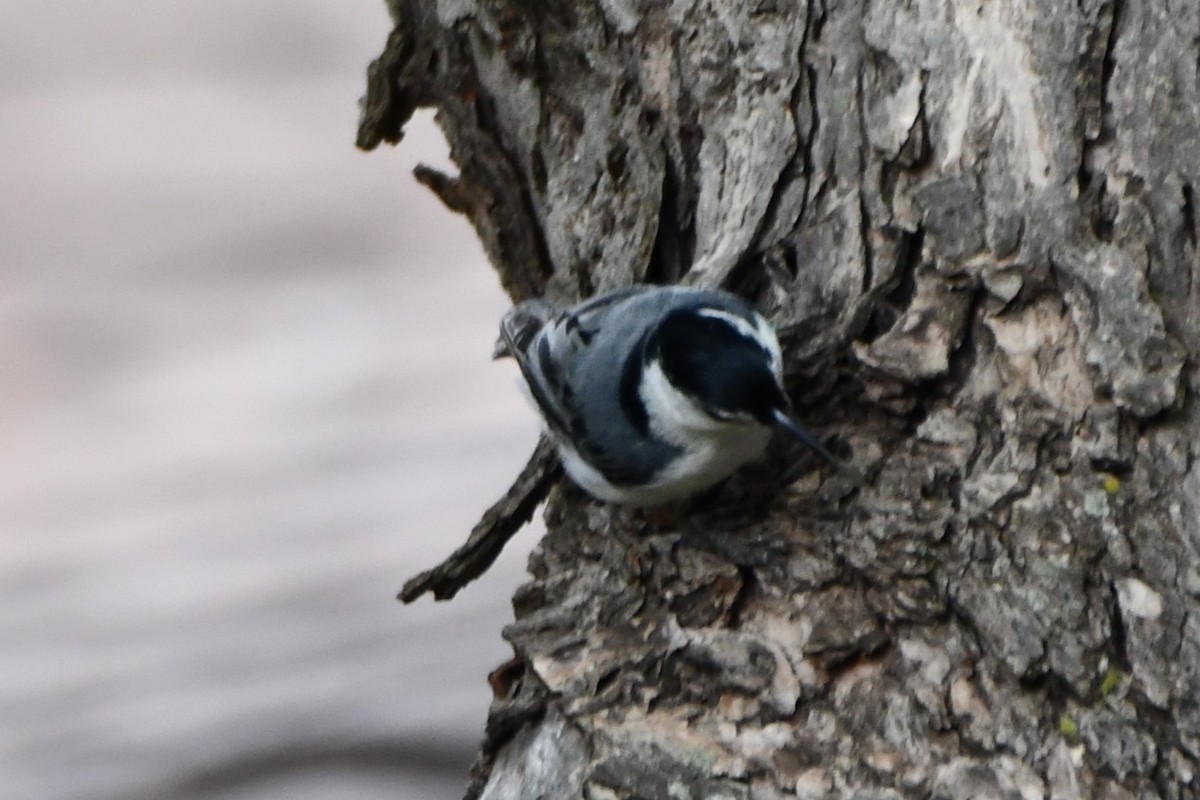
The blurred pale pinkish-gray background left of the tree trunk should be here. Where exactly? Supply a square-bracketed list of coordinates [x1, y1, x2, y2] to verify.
[0, 0, 540, 800]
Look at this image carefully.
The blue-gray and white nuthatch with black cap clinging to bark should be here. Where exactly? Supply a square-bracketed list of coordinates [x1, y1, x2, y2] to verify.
[496, 285, 835, 507]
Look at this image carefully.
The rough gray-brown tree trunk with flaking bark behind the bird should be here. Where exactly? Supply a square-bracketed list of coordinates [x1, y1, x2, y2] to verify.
[360, 0, 1200, 800]
